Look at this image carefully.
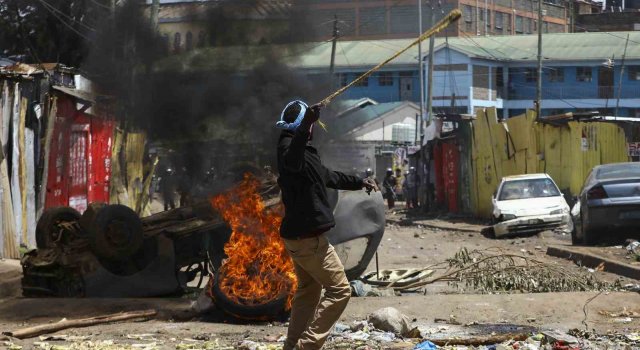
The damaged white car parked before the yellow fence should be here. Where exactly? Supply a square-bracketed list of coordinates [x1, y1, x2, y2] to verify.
[493, 174, 571, 237]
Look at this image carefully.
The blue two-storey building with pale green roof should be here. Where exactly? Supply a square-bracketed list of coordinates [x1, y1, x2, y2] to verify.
[292, 32, 640, 118]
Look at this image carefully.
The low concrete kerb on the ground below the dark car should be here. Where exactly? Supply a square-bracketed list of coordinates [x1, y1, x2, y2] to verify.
[547, 246, 640, 280]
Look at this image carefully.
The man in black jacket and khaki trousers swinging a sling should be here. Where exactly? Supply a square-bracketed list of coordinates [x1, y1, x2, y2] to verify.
[276, 101, 378, 350]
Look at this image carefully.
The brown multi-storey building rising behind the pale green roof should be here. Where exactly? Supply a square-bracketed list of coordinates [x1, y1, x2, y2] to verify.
[300, 0, 567, 40]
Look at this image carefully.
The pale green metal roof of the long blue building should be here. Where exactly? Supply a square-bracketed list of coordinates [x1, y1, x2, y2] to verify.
[159, 31, 640, 71]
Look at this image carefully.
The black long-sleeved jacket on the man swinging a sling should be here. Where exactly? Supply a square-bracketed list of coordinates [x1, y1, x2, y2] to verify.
[278, 127, 363, 239]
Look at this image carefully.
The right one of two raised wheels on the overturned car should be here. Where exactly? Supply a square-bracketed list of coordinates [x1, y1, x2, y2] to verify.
[89, 204, 144, 261]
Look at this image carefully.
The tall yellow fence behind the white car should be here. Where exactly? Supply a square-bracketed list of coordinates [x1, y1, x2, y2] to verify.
[471, 108, 629, 217]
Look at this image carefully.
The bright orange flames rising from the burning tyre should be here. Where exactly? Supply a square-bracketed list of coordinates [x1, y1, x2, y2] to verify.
[211, 174, 297, 310]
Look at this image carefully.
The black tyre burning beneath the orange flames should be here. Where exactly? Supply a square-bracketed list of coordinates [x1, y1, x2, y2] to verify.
[209, 266, 289, 321]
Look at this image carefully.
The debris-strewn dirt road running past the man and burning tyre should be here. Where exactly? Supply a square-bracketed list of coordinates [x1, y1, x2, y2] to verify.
[0, 209, 640, 349]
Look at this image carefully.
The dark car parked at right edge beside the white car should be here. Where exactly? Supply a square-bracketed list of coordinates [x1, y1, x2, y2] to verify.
[571, 163, 640, 245]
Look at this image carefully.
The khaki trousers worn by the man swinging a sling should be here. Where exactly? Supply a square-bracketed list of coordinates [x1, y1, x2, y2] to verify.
[284, 235, 351, 350]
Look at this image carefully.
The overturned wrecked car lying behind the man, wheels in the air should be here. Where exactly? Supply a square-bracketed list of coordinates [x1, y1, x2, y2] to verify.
[22, 187, 385, 297]
